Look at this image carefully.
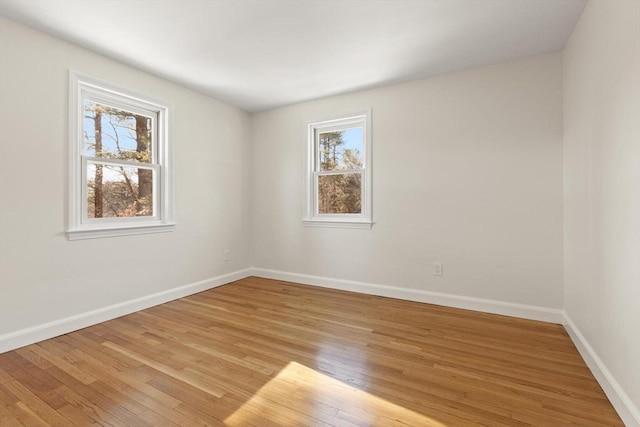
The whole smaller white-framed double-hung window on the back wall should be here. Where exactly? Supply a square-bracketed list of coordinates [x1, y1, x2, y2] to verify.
[303, 112, 372, 228]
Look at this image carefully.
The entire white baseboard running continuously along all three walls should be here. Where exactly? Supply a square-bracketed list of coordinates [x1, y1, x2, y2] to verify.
[0, 268, 640, 427]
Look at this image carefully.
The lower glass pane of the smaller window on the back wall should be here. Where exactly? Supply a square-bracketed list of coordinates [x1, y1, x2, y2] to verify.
[318, 173, 362, 214]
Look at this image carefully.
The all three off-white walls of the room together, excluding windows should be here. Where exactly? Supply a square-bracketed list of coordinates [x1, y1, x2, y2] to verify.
[0, 6, 640, 423]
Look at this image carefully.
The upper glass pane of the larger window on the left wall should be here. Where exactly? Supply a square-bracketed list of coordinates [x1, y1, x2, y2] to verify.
[82, 100, 153, 163]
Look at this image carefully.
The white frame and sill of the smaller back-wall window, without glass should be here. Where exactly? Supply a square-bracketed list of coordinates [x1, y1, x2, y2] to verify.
[302, 110, 373, 228]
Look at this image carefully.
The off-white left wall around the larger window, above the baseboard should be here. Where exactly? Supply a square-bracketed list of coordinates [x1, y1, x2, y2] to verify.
[0, 18, 250, 342]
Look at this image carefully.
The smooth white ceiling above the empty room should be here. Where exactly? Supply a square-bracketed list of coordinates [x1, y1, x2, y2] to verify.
[0, 0, 585, 111]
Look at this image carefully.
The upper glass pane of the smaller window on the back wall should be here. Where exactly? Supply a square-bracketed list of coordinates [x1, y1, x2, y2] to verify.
[317, 127, 364, 171]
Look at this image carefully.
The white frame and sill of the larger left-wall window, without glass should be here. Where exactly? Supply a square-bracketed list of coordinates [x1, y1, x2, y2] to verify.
[67, 70, 175, 240]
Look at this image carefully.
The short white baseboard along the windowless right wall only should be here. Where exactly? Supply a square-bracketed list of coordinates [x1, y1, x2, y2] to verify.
[562, 312, 640, 427]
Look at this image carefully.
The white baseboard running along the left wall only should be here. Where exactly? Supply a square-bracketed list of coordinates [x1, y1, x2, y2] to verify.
[0, 269, 250, 353]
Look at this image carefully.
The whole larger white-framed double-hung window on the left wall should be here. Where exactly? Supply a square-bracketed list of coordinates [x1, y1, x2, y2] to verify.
[68, 72, 174, 240]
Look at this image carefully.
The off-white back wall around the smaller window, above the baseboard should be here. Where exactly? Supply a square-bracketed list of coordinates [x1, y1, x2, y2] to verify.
[252, 54, 563, 309]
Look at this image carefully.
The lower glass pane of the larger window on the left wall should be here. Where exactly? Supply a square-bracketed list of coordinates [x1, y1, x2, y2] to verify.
[87, 163, 153, 218]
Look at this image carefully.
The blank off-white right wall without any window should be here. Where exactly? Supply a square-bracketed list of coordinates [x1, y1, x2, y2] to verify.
[564, 1, 640, 425]
